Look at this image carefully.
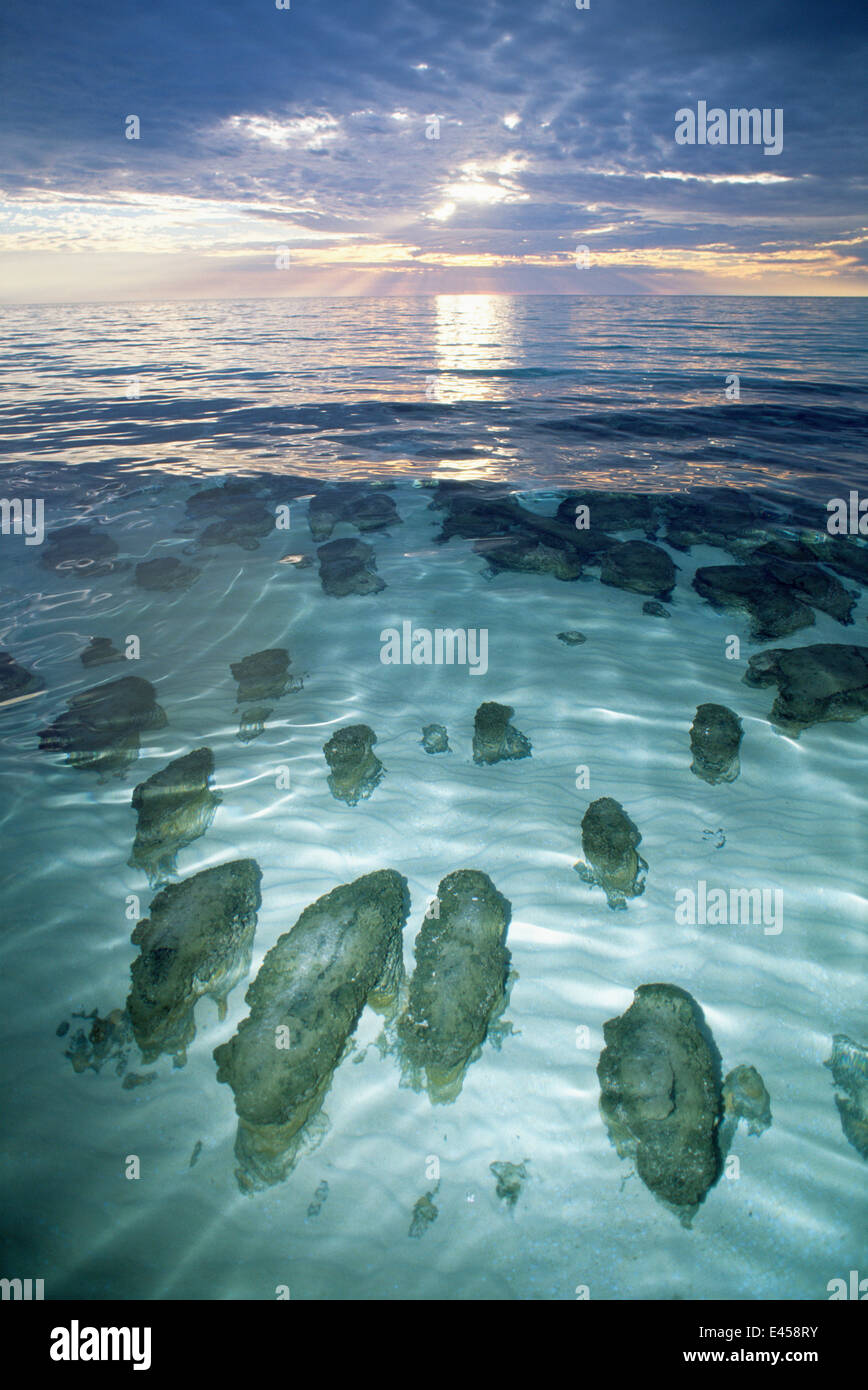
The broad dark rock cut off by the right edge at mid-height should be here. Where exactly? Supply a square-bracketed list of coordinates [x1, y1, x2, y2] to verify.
[743, 642, 868, 738]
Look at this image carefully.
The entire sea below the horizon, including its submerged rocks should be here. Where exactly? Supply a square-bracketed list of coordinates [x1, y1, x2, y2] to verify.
[0, 295, 868, 1301]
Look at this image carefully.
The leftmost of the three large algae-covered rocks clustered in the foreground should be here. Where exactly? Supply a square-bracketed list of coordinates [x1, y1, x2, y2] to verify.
[127, 859, 262, 1066]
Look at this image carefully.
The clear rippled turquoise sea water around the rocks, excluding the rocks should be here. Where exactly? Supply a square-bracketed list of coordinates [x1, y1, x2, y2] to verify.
[0, 295, 868, 1300]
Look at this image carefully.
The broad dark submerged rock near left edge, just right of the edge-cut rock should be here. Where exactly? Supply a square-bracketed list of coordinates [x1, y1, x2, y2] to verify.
[39, 676, 168, 774]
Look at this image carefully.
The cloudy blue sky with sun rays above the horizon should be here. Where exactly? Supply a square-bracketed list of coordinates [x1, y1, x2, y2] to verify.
[0, 0, 868, 303]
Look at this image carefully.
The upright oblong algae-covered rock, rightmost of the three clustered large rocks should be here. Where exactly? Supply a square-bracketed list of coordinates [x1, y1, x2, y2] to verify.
[398, 869, 512, 1104]
